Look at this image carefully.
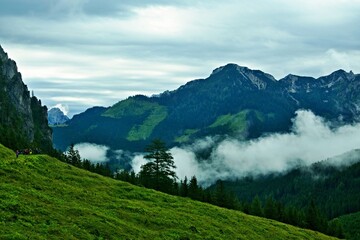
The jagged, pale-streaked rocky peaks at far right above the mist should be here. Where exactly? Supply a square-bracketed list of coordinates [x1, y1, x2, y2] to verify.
[279, 70, 360, 122]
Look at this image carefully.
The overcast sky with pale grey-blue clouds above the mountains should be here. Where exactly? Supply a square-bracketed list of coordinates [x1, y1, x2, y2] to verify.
[0, 0, 360, 116]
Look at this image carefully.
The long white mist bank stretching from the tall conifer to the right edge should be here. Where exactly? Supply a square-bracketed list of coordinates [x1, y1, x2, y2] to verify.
[131, 110, 360, 186]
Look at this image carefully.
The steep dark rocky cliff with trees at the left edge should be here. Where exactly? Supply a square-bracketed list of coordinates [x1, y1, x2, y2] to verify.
[0, 46, 52, 150]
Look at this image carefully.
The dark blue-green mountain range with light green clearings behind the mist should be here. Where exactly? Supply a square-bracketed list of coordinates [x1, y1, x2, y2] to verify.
[53, 64, 360, 151]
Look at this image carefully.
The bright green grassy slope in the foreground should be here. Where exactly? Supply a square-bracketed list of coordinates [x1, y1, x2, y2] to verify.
[0, 145, 338, 239]
